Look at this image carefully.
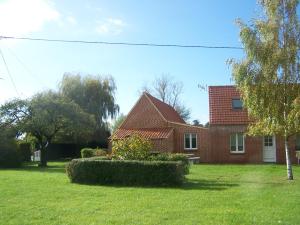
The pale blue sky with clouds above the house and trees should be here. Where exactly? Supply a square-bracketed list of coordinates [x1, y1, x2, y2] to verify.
[0, 0, 258, 123]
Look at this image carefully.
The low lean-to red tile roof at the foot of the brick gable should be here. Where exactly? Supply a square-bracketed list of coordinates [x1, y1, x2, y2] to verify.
[110, 128, 173, 139]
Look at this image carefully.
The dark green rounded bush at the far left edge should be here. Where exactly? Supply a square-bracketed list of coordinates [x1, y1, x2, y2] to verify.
[0, 149, 22, 168]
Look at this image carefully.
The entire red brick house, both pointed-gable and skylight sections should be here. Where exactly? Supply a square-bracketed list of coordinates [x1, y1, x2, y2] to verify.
[110, 86, 300, 163]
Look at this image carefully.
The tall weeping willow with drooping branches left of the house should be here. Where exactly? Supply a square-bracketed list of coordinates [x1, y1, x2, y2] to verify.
[59, 73, 119, 141]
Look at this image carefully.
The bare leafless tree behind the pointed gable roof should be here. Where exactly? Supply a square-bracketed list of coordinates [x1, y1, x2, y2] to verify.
[142, 74, 191, 120]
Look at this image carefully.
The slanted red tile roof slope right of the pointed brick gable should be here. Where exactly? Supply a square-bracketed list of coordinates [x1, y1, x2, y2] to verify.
[144, 92, 185, 124]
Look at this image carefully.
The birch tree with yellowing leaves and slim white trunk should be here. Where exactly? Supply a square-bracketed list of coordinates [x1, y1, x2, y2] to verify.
[230, 0, 300, 180]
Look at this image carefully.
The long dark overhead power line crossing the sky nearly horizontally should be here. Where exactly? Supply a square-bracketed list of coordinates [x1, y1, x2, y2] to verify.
[0, 36, 243, 50]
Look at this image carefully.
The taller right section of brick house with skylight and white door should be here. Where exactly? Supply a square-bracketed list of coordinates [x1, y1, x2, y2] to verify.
[208, 86, 300, 163]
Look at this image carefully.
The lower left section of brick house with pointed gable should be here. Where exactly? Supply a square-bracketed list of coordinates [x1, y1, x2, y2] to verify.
[110, 93, 209, 158]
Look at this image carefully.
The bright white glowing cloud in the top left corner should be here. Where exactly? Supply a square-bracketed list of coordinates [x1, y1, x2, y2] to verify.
[0, 0, 60, 36]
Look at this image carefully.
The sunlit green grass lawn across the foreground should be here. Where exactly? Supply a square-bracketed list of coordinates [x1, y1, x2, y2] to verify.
[0, 162, 300, 225]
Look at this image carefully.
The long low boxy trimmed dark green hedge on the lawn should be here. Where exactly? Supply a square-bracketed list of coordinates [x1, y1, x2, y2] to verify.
[66, 159, 184, 186]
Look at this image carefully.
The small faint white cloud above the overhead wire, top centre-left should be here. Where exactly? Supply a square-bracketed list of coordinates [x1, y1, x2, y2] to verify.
[96, 18, 127, 35]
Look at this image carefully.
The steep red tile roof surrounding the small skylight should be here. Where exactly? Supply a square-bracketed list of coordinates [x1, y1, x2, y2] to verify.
[208, 86, 249, 125]
